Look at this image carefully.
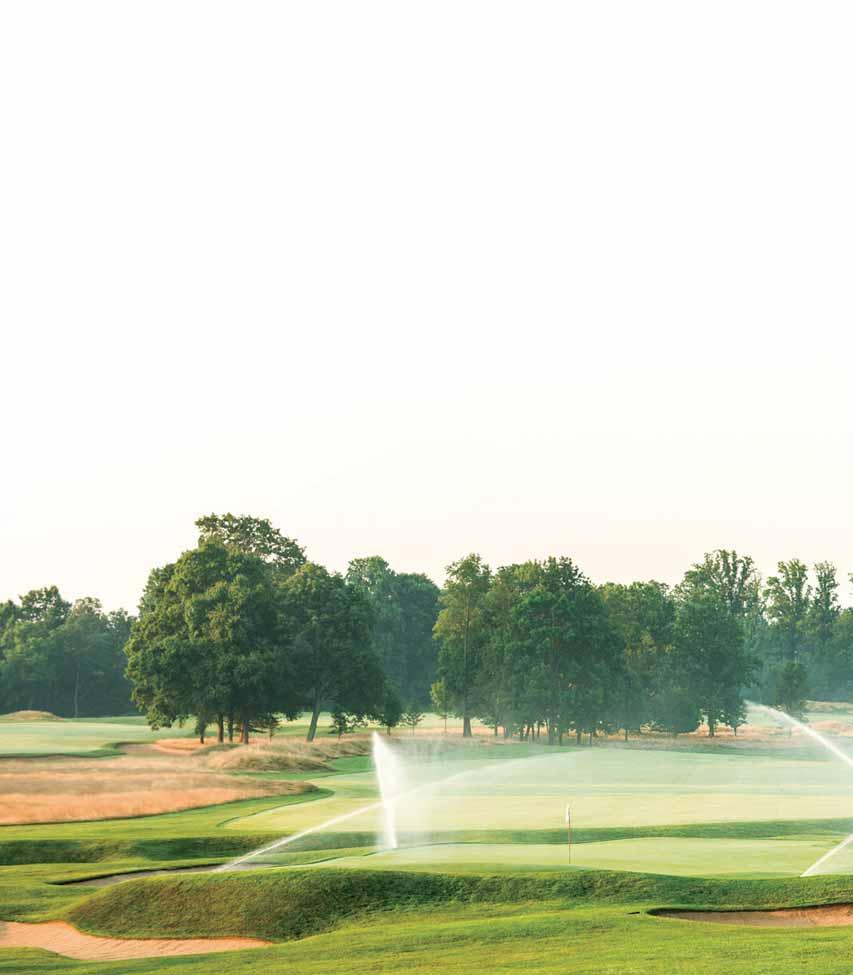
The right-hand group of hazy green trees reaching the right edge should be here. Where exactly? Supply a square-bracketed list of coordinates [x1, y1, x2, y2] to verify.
[432, 550, 853, 743]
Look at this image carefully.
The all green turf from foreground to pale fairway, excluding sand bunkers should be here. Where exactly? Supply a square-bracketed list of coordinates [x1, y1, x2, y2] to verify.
[0, 722, 853, 975]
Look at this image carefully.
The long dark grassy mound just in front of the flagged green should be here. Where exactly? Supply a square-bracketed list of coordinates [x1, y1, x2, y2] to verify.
[67, 869, 853, 940]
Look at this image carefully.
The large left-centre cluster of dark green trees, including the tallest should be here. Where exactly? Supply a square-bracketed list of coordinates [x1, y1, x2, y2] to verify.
[126, 514, 438, 742]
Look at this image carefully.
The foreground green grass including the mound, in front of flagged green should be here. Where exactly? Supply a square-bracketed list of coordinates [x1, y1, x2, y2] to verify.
[0, 871, 853, 975]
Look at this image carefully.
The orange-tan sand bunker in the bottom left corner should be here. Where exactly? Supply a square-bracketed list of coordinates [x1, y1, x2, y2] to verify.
[0, 921, 271, 961]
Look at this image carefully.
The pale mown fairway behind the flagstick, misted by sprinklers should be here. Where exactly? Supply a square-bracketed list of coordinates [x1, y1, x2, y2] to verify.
[229, 748, 853, 833]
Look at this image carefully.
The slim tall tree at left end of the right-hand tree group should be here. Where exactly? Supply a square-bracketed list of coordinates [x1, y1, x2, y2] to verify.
[434, 554, 491, 738]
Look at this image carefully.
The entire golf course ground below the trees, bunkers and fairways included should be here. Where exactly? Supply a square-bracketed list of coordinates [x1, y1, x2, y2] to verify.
[0, 712, 853, 975]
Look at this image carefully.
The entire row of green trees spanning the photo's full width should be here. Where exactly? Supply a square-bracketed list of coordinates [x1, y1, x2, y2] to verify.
[0, 514, 853, 742]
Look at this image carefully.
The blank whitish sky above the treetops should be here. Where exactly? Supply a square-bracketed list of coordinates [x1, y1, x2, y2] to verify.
[0, 0, 853, 609]
